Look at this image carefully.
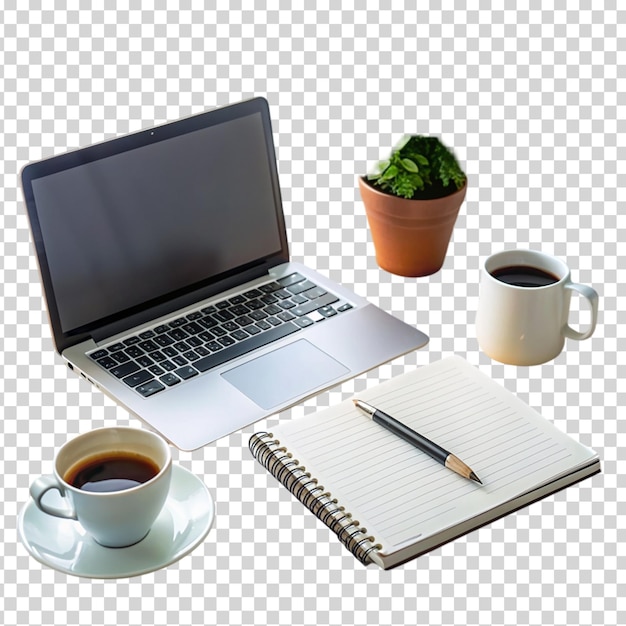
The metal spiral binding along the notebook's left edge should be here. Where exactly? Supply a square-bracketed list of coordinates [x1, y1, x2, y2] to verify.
[249, 432, 381, 565]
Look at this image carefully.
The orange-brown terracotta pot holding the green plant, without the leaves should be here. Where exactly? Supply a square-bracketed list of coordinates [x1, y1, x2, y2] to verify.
[359, 177, 467, 276]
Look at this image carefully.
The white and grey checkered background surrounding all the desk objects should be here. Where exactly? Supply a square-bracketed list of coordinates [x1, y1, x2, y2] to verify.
[0, 0, 626, 626]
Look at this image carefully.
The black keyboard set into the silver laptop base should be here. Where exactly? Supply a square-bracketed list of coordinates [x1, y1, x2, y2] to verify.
[89, 273, 352, 397]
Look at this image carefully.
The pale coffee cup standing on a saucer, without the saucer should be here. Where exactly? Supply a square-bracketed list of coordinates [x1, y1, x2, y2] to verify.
[30, 428, 172, 548]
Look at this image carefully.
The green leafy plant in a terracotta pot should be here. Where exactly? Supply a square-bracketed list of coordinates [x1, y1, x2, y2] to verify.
[359, 135, 467, 276]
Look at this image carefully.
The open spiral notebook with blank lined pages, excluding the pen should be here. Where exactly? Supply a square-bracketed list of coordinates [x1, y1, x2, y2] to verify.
[249, 356, 600, 569]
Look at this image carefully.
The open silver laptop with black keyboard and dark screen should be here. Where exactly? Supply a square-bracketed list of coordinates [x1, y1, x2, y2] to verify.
[22, 98, 428, 450]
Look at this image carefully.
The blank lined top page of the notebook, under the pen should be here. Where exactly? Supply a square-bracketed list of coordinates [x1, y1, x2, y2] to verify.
[273, 357, 595, 553]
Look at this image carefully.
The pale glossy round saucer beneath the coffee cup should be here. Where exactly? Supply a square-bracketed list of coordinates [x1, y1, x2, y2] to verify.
[18, 465, 215, 578]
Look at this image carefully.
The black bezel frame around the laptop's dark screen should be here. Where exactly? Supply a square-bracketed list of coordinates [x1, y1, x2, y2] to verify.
[21, 97, 289, 354]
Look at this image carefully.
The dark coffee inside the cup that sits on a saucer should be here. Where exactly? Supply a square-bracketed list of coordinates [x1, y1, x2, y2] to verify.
[63, 452, 159, 493]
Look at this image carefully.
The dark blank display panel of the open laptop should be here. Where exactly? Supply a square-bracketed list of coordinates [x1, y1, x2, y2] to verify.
[21, 98, 283, 342]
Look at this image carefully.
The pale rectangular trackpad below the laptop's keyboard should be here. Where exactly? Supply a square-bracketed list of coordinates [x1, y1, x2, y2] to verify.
[222, 339, 348, 409]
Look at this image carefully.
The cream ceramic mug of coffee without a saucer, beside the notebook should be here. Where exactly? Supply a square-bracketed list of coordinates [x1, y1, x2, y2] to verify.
[476, 250, 598, 365]
